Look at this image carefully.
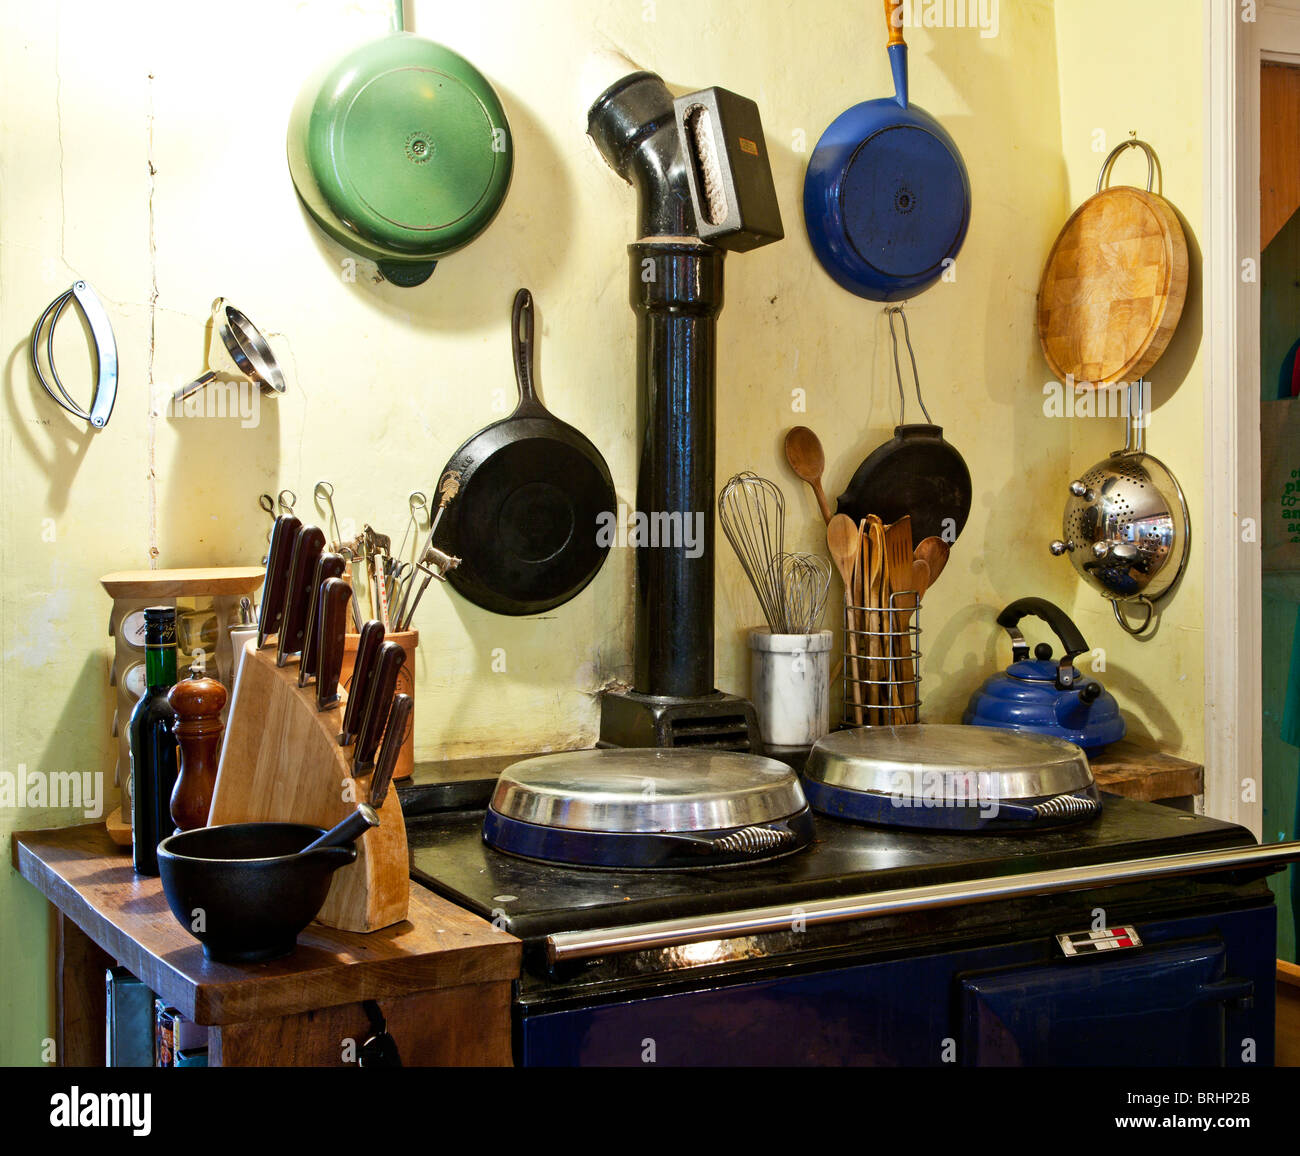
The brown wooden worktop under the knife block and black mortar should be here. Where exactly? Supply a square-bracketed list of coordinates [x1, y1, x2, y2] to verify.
[13, 822, 521, 1025]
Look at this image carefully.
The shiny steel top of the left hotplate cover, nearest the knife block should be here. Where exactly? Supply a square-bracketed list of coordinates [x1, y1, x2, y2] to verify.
[491, 748, 807, 834]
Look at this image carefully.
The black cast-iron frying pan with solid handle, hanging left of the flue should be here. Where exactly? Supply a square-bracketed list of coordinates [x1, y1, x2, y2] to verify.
[437, 289, 616, 615]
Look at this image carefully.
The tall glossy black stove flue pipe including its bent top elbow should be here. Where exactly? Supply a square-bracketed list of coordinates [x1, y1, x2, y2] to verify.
[588, 73, 725, 698]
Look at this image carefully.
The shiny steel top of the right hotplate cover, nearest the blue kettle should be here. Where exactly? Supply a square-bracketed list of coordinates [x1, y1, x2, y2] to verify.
[803, 724, 1092, 805]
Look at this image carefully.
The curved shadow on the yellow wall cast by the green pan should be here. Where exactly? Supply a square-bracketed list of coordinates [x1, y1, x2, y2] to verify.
[285, 81, 576, 334]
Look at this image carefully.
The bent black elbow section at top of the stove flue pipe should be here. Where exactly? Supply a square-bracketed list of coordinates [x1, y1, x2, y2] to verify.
[586, 72, 697, 238]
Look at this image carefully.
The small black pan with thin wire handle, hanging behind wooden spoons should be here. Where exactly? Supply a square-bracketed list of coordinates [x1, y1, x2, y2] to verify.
[836, 306, 971, 545]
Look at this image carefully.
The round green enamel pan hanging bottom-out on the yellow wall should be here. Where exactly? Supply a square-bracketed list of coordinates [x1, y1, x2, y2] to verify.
[287, 31, 514, 286]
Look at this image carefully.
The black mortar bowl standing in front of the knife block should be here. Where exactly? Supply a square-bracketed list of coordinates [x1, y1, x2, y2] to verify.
[159, 823, 356, 964]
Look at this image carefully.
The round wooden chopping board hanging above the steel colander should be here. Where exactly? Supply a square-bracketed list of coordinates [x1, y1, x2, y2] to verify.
[1039, 186, 1187, 386]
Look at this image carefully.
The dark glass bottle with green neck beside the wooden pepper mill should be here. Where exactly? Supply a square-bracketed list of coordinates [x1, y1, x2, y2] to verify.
[129, 606, 177, 875]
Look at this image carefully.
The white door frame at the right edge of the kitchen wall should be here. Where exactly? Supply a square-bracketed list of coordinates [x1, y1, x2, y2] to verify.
[1200, 0, 1300, 837]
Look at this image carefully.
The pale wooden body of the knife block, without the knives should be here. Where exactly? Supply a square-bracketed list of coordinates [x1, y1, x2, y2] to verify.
[208, 640, 410, 931]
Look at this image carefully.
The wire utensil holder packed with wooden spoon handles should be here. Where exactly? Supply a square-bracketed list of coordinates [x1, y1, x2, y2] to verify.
[840, 590, 922, 727]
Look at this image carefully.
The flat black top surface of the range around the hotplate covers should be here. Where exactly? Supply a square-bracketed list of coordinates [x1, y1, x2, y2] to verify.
[407, 796, 1255, 940]
